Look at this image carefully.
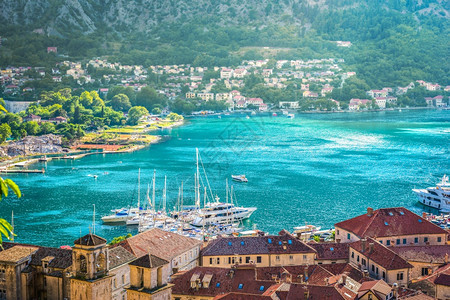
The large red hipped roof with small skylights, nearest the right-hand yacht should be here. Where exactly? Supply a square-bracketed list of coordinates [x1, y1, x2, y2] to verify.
[335, 207, 446, 238]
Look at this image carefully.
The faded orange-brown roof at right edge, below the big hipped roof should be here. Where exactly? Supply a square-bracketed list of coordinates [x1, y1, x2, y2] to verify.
[389, 245, 450, 264]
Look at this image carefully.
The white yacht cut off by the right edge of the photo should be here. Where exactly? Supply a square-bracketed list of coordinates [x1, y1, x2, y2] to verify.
[413, 175, 450, 212]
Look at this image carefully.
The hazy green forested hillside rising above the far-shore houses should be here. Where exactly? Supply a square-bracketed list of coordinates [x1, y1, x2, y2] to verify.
[0, 0, 450, 88]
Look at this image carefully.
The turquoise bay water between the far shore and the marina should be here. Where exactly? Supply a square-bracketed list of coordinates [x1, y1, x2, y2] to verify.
[0, 110, 450, 246]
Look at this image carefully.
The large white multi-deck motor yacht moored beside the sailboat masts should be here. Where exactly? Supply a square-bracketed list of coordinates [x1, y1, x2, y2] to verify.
[191, 202, 256, 227]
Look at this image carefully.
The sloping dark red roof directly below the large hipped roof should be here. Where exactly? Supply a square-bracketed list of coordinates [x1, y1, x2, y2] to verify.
[349, 238, 413, 270]
